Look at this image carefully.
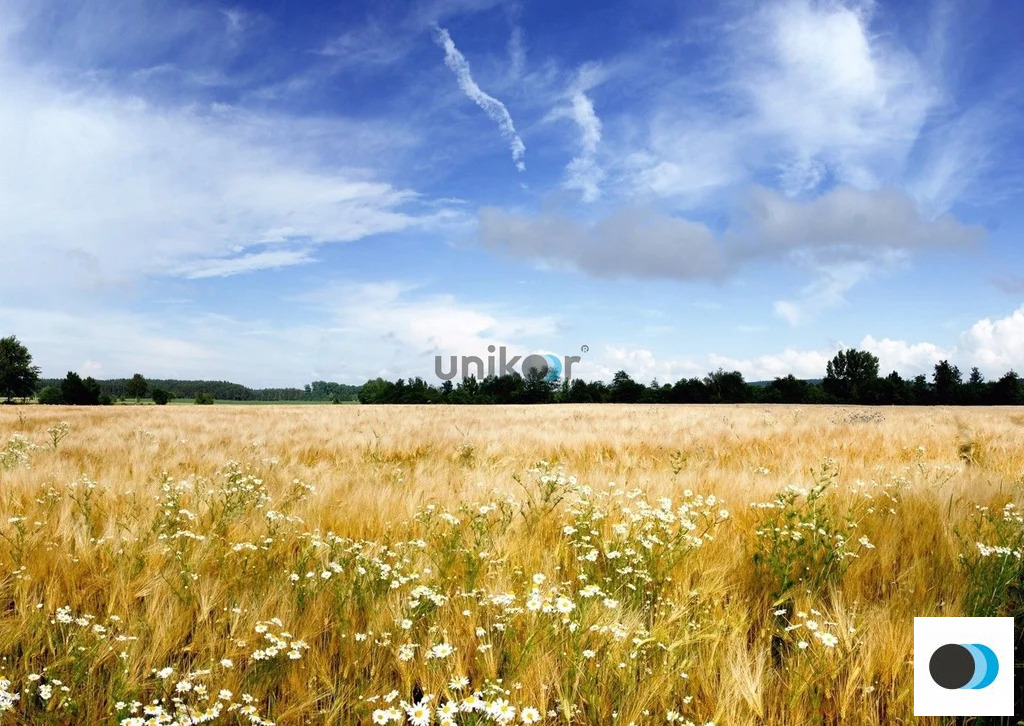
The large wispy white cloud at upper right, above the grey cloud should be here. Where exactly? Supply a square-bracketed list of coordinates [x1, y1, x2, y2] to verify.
[624, 0, 948, 202]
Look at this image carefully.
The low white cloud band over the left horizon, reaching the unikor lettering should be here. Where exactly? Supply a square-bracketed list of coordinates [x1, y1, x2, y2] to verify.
[0, 282, 558, 386]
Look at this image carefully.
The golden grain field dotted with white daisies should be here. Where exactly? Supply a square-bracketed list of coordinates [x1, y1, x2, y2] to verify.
[0, 404, 1024, 725]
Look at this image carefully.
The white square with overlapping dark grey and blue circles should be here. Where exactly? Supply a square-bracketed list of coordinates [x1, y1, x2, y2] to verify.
[913, 617, 1017, 717]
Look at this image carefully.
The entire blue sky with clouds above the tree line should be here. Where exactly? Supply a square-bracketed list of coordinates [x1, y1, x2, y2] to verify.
[0, 0, 1024, 386]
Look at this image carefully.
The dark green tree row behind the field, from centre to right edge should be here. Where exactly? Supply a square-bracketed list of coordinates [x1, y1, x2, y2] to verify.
[358, 348, 1024, 405]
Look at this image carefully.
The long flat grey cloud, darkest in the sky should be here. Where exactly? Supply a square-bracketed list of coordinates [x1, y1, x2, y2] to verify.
[479, 188, 983, 280]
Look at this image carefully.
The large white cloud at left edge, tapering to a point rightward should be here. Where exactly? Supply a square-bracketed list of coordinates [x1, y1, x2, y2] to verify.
[0, 27, 447, 292]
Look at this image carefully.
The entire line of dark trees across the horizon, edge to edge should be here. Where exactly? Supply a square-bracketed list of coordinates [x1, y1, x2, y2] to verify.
[0, 336, 1024, 405]
